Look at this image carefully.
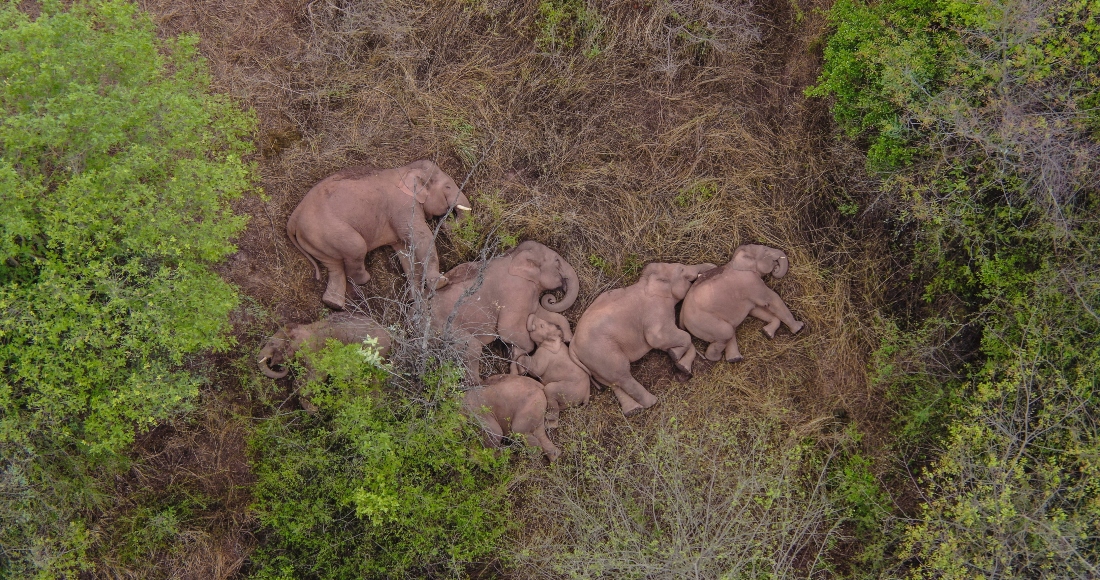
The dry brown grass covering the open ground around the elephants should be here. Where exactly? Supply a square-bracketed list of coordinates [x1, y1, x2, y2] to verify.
[124, 0, 889, 578]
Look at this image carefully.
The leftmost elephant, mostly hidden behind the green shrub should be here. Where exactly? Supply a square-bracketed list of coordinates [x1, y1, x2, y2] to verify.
[257, 313, 392, 379]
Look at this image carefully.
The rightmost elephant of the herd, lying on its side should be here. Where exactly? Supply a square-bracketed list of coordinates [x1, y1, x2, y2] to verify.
[680, 244, 803, 362]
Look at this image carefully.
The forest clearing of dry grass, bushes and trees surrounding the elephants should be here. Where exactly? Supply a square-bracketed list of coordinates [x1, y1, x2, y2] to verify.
[0, 0, 1100, 579]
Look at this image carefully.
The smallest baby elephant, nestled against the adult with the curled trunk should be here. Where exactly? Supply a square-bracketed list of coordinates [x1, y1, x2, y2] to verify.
[516, 314, 592, 428]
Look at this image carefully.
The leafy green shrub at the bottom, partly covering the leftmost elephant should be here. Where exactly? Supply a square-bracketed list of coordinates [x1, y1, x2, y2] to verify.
[251, 341, 509, 578]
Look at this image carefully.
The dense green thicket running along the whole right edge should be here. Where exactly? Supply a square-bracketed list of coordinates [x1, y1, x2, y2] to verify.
[810, 0, 1100, 578]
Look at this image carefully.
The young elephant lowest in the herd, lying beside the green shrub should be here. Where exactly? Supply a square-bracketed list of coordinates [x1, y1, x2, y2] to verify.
[462, 374, 561, 461]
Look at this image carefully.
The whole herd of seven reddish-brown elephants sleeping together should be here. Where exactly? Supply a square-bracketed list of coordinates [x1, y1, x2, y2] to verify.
[259, 160, 803, 461]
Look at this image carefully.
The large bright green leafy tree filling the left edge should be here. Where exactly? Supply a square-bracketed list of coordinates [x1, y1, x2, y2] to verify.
[0, 1, 254, 577]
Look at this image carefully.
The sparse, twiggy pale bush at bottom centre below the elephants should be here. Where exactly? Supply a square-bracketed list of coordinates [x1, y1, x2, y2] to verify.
[514, 418, 845, 579]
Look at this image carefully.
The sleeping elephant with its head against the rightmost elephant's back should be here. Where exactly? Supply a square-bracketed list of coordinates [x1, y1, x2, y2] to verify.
[569, 262, 717, 417]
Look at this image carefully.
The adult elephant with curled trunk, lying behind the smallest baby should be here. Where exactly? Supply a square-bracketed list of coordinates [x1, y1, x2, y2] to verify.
[431, 241, 580, 382]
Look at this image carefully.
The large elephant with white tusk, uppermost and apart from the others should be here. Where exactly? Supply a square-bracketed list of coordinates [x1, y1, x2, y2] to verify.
[286, 160, 471, 310]
